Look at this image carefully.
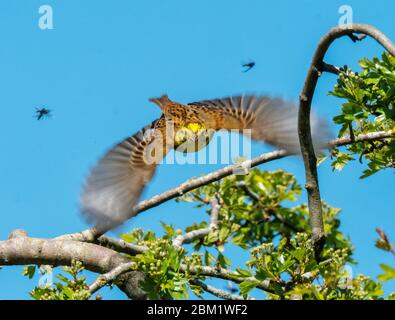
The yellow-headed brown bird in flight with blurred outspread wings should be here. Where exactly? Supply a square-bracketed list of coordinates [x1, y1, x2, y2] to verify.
[81, 95, 327, 229]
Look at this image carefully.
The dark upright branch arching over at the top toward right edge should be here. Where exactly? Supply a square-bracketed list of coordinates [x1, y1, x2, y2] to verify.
[298, 24, 395, 258]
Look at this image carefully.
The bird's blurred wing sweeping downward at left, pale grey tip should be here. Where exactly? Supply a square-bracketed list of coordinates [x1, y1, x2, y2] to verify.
[81, 117, 168, 230]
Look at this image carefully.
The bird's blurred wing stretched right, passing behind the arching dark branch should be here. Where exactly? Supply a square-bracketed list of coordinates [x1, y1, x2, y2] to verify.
[189, 95, 329, 153]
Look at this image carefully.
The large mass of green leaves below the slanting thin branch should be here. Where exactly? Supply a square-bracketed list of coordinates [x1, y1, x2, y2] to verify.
[115, 169, 392, 299]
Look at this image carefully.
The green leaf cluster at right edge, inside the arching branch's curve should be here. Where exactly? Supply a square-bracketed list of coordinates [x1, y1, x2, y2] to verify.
[330, 53, 395, 178]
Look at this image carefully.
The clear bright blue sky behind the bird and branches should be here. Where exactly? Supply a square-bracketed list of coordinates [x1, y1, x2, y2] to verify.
[0, 0, 395, 299]
